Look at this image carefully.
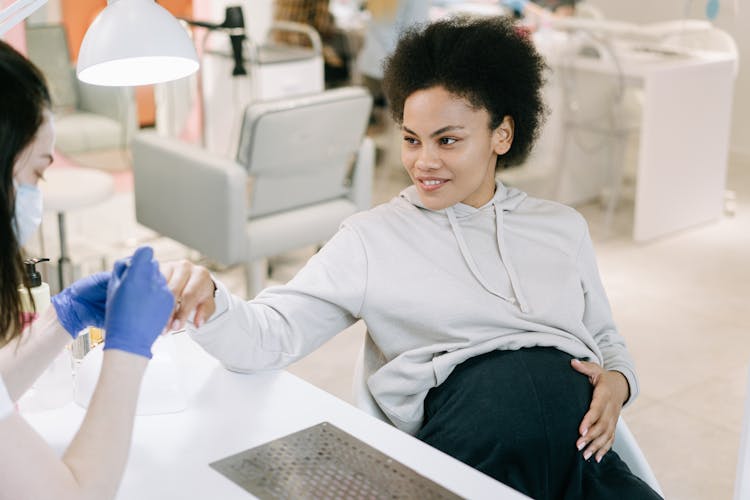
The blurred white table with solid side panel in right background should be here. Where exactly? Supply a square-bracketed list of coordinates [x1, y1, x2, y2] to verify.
[537, 34, 736, 241]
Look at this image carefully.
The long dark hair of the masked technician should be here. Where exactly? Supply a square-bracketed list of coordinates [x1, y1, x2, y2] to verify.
[0, 41, 51, 345]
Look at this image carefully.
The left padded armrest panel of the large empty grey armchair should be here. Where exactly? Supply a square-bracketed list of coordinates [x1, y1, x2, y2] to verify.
[132, 132, 247, 265]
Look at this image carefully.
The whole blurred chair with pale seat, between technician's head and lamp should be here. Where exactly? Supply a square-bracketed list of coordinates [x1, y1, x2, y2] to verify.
[26, 24, 138, 162]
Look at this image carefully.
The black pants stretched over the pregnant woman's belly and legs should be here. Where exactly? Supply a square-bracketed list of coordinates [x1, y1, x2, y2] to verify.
[417, 347, 661, 500]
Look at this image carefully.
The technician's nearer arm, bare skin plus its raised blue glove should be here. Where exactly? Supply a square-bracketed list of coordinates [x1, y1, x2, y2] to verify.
[0, 248, 174, 500]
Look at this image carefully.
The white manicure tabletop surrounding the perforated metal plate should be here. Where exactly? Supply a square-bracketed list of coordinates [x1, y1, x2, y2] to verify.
[25, 334, 526, 500]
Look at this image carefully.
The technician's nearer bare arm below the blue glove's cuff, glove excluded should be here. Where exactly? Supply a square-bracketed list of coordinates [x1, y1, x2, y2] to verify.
[0, 350, 148, 500]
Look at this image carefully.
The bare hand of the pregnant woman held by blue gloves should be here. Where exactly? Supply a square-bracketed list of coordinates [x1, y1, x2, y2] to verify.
[161, 260, 216, 330]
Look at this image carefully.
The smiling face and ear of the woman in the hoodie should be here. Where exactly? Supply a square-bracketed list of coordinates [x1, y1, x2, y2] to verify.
[401, 86, 513, 210]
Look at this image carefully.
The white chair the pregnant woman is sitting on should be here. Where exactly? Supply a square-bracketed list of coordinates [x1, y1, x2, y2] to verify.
[352, 333, 664, 500]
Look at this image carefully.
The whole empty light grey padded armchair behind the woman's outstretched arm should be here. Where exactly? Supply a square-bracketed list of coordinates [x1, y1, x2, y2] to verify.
[132, 87, 374, 297]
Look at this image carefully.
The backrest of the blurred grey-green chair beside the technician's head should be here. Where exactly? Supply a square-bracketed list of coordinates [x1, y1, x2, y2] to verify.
[26, 24, 78, 113]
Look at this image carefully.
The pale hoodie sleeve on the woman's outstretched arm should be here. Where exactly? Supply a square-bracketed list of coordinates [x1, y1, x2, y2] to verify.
[185, 225, 367, 372]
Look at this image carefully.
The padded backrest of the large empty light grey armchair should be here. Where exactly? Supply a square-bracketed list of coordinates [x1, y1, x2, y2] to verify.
[237, 87, 372, 219]
